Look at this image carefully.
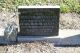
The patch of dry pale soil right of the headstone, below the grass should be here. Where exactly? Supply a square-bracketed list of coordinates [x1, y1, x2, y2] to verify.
[59, 13, 80, 29]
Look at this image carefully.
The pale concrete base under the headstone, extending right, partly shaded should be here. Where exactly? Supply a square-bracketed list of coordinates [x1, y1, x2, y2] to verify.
[18, 29, 80, 45]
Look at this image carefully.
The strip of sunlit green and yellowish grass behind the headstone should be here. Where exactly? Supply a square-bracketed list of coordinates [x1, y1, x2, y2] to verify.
[0, 0, 80, 13]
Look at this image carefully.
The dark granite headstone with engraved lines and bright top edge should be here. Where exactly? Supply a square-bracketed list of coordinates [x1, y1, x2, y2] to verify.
[18, 6, 60, 36]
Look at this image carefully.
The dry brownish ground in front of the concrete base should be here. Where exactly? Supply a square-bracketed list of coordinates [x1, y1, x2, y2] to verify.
[0, 42, 80, 53]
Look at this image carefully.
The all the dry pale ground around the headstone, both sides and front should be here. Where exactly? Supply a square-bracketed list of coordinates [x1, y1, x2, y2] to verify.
[0, 12, 80, 53]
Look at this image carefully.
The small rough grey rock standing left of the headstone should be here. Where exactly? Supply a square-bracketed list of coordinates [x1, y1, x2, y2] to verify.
[4, 23, 18, 41]
